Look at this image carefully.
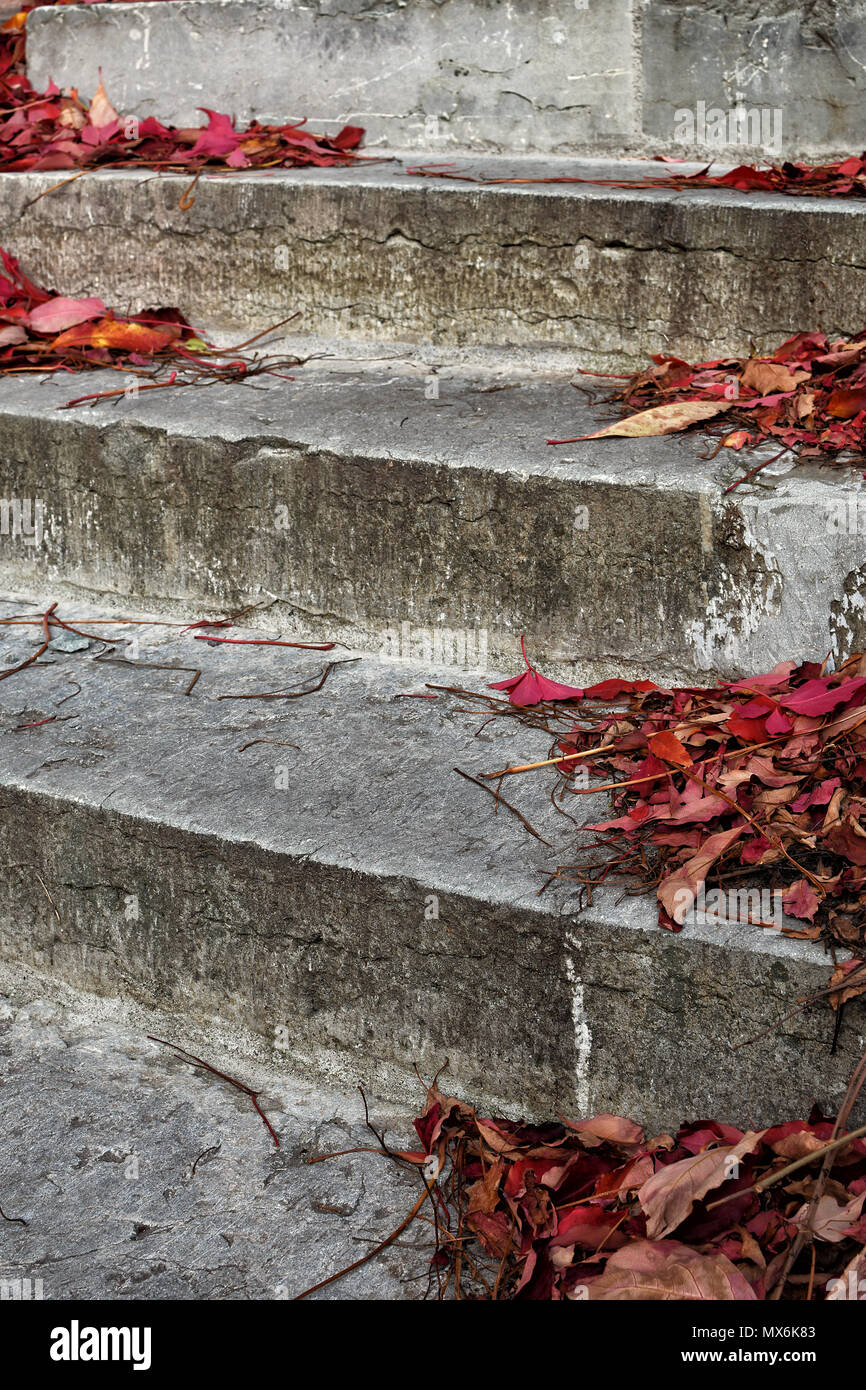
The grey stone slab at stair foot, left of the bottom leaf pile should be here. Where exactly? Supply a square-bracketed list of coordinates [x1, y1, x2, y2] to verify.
[0, 967, 428, 1301]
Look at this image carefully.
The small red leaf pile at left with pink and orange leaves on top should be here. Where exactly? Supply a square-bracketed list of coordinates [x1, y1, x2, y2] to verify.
[0, 247, 297, 409]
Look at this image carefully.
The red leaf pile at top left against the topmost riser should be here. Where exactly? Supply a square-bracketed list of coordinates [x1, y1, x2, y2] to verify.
[0, 6, 364, 174]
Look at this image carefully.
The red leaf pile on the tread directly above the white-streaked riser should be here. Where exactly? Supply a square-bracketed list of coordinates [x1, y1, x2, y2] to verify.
[485, 653, 866, 1004]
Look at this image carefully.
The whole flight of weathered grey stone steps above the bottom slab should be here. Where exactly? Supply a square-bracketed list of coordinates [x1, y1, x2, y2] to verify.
[0, 0, 866, 1178]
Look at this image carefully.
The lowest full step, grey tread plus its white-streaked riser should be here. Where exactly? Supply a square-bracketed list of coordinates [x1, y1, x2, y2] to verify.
[0, 599, 863, 1129]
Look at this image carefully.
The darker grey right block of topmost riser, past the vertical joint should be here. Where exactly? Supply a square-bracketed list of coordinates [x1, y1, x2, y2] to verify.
[642, 0, 866, 158]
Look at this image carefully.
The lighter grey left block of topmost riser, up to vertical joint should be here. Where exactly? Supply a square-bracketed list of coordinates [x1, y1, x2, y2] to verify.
[28, 0, 635, 153]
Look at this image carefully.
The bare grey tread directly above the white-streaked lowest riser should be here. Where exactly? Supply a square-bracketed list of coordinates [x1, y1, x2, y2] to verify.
[0, 600, 820, 960]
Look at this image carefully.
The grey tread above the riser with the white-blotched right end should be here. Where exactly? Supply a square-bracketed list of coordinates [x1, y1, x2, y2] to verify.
[0, 361, 839, 492]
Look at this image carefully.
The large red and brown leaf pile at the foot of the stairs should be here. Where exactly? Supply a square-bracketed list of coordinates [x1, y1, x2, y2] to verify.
[405, 1058, 866, 1301]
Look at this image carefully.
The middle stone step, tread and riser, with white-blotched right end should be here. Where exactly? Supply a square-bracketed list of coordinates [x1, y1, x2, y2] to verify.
[0, 354, 866, 682]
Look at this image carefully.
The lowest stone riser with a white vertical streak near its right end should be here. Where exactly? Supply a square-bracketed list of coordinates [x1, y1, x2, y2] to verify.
[0, 792, 862, 1129]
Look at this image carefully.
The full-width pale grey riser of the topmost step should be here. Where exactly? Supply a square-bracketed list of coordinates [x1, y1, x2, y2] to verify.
[28, 0, 866, 160]
